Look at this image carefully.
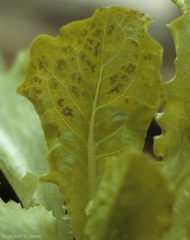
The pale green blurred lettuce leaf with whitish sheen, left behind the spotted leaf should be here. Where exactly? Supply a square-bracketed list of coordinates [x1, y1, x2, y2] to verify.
[0, 51, 48, 179]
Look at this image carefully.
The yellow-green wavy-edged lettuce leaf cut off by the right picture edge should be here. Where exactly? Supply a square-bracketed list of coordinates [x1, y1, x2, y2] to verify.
[154, 0, 190, 240]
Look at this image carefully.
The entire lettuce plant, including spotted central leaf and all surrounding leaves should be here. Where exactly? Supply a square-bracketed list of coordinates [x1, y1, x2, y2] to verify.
[0, 0, 190, 240]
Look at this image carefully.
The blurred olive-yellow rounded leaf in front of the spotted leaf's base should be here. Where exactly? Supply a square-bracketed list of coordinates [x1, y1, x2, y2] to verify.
[85, 152, 174, 240]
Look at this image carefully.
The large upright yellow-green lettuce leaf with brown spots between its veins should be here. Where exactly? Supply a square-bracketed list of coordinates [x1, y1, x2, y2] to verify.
[18, 7, 162, 240]
